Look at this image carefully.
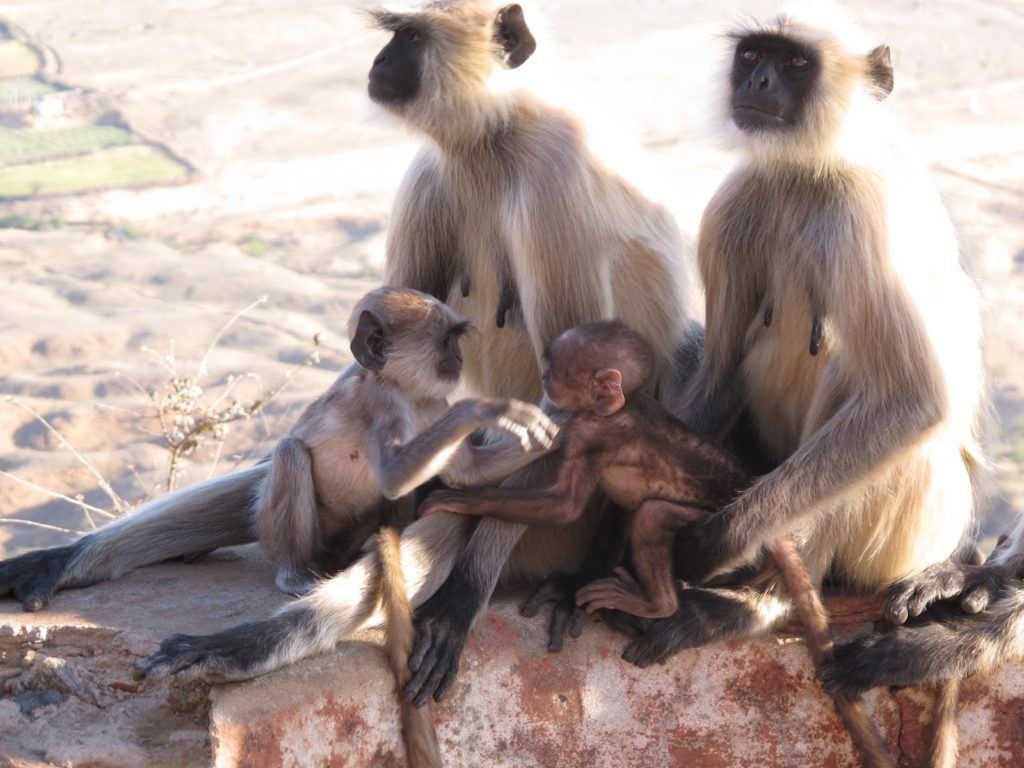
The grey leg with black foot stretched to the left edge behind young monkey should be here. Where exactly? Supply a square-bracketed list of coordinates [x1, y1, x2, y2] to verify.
[0, 464, 267, 611]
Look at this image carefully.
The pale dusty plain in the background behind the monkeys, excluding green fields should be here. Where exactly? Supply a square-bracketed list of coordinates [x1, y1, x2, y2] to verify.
[0, 0, 1024, 554]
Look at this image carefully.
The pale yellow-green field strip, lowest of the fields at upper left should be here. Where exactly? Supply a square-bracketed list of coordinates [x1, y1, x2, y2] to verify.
[0, 144, 188, 198]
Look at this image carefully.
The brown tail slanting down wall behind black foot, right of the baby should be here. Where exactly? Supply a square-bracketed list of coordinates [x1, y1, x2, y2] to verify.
[769, 537, 896, 768]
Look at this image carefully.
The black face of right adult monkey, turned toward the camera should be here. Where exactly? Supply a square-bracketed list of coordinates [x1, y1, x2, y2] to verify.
[731, 35, 821, 131]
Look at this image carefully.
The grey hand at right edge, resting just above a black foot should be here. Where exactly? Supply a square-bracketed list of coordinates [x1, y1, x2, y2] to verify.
[885, 560, 1015, 625]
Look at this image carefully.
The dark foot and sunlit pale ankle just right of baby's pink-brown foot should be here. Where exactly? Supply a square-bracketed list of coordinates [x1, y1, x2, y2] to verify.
[623, 588, 793, 668]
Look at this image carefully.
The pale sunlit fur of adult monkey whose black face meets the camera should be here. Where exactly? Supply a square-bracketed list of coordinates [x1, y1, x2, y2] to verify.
[690, 4, 983, 589]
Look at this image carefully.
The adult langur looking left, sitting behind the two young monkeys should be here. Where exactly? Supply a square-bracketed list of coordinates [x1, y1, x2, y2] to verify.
[128, 0, 701, 703]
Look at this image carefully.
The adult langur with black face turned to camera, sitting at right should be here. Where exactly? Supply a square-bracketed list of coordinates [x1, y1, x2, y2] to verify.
[625, 4, 983, 679]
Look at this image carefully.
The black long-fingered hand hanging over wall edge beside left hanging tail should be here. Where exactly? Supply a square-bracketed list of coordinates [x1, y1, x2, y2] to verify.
[401, 570, 482, 707]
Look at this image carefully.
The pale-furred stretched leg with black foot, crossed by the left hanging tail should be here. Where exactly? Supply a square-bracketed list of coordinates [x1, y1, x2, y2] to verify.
[133, 515, 470, 680]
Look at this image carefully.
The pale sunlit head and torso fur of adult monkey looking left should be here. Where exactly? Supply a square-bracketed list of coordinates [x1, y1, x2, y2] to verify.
[378, 0, 695, 398]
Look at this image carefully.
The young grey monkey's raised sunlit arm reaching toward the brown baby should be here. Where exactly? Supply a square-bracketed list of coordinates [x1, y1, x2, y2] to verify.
[367, 399, 557, 499]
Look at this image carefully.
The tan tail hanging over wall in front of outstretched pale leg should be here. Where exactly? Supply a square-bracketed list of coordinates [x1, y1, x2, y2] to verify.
[377, 528, 442, 768]
